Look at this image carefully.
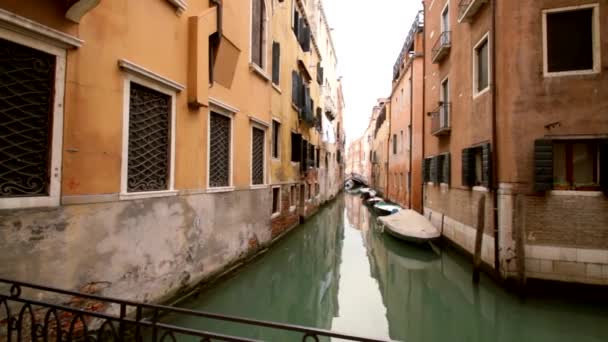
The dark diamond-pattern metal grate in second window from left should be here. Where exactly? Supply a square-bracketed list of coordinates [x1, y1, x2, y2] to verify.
[127, 83, 171, 192]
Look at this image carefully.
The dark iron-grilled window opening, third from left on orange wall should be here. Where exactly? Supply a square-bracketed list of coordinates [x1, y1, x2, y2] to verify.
[209, 112, 232, 188]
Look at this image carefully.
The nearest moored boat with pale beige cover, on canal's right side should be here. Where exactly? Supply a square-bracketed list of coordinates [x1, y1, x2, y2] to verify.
[379, 209, 441, 243]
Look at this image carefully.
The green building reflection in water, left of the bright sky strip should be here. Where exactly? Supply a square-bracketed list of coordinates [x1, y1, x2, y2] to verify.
[166, 199, 344, 341]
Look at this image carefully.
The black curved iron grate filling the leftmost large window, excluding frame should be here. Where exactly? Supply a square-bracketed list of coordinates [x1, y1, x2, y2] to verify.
[0, 39, 55, 197]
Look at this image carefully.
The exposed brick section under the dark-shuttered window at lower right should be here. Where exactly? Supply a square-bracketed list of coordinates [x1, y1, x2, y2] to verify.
[525, 194, 608, 248]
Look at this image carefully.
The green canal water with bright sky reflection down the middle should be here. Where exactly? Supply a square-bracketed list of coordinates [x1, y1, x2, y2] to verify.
[167, 195, 608, 342]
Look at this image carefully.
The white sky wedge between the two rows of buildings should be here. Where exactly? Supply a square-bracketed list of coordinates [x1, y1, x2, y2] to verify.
[323, 0, 422, 143]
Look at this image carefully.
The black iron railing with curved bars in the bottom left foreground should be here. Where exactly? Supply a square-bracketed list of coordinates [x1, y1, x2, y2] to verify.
[0, 278, 390, 342]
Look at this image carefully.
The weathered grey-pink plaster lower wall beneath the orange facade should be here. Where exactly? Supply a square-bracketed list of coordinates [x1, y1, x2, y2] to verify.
[0, 188, 272, 302]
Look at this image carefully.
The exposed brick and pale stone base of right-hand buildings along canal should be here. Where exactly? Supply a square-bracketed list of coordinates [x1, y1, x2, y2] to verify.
[424, 183, 608, 285]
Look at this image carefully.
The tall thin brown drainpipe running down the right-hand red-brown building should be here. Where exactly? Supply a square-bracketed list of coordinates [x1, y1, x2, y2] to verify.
[491, 0, 500, 277]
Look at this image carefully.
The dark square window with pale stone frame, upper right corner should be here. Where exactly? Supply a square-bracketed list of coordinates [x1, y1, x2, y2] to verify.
[543, 4, 600, 76]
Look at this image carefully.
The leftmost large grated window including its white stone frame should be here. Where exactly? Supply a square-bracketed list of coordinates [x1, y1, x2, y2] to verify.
[0, 36, 65, 209]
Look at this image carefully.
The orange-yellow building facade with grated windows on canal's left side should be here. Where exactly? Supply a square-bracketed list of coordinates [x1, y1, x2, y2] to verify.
[0, 0, 342, 301]
